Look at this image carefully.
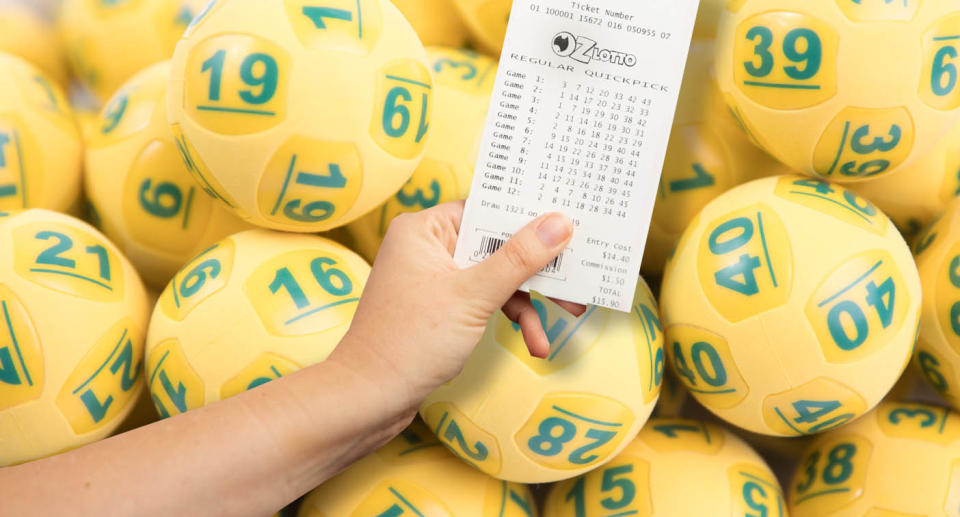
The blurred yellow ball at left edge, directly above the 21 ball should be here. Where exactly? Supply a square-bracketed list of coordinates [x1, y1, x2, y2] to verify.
[0, 53, 83, 212]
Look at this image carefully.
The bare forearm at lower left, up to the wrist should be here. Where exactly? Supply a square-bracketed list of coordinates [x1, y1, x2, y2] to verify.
[0, 332, 413, 516]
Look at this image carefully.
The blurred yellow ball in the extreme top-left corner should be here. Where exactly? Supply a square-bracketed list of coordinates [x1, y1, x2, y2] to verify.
[0, 3, 69, 85]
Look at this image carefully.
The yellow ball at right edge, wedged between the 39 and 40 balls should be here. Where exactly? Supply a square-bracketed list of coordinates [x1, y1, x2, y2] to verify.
[850, 124, 960, 240]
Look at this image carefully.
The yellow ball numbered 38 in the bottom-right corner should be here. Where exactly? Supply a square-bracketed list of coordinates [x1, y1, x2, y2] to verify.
[787, 402, 960, 517]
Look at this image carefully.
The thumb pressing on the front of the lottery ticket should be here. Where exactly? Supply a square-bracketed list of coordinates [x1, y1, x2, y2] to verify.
[465, 213, 573, 307]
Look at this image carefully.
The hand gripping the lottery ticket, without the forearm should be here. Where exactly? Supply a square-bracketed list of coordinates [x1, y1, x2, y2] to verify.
[329, 202, 584, 406]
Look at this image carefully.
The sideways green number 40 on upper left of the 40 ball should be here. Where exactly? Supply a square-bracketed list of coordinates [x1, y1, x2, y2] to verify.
[708, 217, 761, 296]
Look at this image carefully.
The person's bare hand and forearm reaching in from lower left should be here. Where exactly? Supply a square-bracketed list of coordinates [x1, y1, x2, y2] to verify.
[0, 203, 583, 517]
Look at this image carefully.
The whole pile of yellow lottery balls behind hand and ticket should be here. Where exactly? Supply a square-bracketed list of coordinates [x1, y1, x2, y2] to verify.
[0, 0, 960, 517]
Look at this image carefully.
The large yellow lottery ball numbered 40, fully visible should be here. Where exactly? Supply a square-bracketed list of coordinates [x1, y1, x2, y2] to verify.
[661, 176, 921, 436]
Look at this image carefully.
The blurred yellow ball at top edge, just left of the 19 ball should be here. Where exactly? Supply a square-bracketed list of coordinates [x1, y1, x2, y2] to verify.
[59, 0, 209, 101]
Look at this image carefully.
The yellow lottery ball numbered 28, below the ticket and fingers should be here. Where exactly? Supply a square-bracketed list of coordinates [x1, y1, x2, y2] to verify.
[420, 280, 663, 483]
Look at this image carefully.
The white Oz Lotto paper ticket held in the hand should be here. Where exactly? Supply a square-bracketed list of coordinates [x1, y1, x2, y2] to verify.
[455, 0, 699, 311]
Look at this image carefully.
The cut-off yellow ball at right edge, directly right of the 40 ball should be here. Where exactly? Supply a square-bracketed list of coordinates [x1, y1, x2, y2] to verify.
[914, 200, 960, 407]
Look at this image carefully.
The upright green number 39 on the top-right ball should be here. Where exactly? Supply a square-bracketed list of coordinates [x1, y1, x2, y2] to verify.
[743, 25, 823, 81]
